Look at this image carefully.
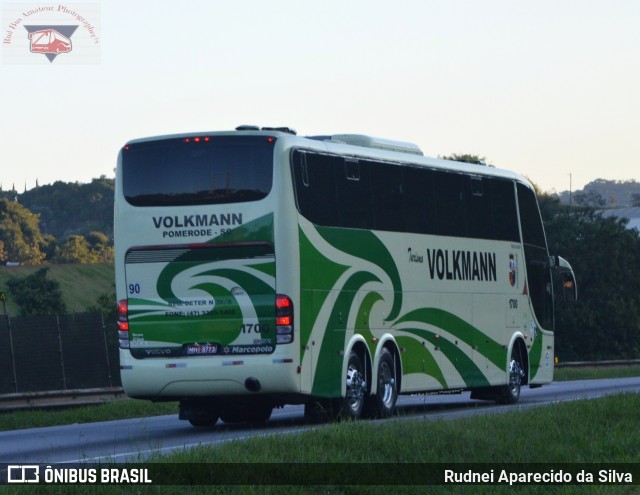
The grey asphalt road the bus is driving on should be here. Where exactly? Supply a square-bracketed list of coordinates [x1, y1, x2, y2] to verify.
[0, 377, 640, 464]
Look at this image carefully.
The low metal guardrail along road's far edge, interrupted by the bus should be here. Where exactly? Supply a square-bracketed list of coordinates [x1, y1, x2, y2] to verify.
[0, 359, 640, 412]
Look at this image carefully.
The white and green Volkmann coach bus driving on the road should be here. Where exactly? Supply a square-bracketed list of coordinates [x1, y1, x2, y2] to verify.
[115, 126, 576, 426]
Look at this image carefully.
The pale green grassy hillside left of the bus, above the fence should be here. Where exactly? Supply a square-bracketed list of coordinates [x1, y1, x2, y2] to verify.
[0, 264, 116, 316]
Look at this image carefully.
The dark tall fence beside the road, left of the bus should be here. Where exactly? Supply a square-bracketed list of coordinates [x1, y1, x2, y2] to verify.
[0, 313, 120, 394]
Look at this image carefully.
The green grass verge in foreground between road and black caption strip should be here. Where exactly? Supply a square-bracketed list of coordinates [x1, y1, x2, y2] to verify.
[162, 394, 640, 464]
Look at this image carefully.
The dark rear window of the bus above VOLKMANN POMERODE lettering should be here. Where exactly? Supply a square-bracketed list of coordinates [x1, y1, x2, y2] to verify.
[122, 136, 275, 206]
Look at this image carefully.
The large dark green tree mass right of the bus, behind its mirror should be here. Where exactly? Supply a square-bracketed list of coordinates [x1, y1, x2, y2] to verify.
[539, 195, 640, 361]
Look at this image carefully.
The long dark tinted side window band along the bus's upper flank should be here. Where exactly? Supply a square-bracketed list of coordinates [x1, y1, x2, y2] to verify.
[292, 150, 520, 242]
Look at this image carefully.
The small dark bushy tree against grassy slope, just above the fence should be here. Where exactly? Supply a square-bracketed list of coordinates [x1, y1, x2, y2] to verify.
[7, 268, 66, 316]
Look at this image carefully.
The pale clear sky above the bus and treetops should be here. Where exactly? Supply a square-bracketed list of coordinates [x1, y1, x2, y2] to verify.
[0, 0, 640, 192]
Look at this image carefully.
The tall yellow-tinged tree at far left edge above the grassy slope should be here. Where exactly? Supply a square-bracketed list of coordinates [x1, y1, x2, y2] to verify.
[0, 198, 47, 265]
